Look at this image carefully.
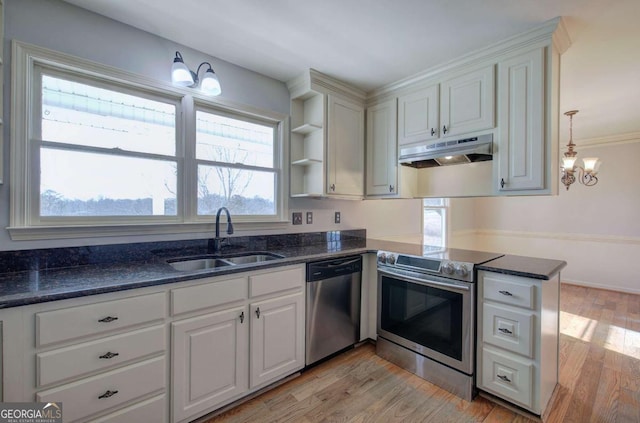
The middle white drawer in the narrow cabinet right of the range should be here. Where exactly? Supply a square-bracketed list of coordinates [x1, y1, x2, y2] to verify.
[482, 303, 535, 358]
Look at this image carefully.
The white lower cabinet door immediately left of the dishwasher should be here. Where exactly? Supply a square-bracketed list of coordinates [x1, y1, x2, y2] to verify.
[250, 292, 305, 388]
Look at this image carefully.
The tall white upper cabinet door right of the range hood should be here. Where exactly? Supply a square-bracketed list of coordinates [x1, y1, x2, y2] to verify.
[498, 48, 545, 191]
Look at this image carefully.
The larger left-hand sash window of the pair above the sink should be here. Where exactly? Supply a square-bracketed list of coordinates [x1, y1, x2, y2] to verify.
[36, 67, 178, 223]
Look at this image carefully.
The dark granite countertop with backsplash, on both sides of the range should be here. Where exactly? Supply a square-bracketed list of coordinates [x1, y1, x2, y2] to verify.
[0, 230, 566, 309]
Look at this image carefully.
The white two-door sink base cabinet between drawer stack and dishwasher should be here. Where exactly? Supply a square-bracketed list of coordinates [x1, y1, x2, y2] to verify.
[171, 265, 305, 423]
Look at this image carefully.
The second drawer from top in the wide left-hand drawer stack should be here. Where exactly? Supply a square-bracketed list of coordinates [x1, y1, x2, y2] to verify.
[36, 326, 166, 386]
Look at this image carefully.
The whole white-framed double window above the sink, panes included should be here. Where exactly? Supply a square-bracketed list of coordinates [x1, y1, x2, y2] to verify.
[9, 42, 286, 240]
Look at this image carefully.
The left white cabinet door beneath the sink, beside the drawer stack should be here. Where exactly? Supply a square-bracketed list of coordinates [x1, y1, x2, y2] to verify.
[171, 307, 249, 422]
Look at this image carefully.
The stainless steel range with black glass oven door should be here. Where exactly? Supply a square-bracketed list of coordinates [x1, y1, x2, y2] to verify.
[376, 246, 502, 401]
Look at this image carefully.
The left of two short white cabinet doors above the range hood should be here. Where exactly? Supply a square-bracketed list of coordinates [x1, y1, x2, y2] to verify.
[398, 85, 440, 145]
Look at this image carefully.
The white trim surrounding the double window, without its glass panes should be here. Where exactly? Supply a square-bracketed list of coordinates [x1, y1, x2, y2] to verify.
[7, 40, 289, 240]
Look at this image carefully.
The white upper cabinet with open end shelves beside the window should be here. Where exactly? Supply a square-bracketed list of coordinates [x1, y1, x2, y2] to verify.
[287, 69, 365, 199]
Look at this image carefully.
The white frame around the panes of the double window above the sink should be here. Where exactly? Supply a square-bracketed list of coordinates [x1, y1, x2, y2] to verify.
[7, 40, 289, 240]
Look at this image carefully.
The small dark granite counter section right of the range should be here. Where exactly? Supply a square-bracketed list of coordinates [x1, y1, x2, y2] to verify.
[477, 255, 567, 280]
